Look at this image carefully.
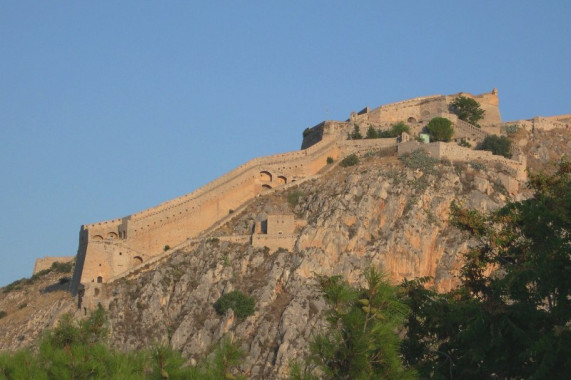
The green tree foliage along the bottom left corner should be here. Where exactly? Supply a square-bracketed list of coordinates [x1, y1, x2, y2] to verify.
[0, 309, 243, 380]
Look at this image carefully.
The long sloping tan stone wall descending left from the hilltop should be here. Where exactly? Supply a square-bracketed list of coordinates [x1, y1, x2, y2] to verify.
[71, 135, 340, 295]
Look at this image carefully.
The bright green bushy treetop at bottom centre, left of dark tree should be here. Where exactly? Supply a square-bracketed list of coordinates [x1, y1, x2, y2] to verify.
[292, 269, 416, 379]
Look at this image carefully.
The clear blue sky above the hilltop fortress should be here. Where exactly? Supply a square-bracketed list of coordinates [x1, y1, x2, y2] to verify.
[0, 0, 571, 285]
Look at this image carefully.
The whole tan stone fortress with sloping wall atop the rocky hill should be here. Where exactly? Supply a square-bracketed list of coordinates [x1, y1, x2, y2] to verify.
[63, 89, 559, 302]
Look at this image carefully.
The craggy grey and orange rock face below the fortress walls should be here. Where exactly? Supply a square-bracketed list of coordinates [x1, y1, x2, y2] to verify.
[101, 156, 520, 379]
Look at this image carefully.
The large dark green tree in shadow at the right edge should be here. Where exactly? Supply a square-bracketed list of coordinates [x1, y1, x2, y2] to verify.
[403, 161, 571, 379]
